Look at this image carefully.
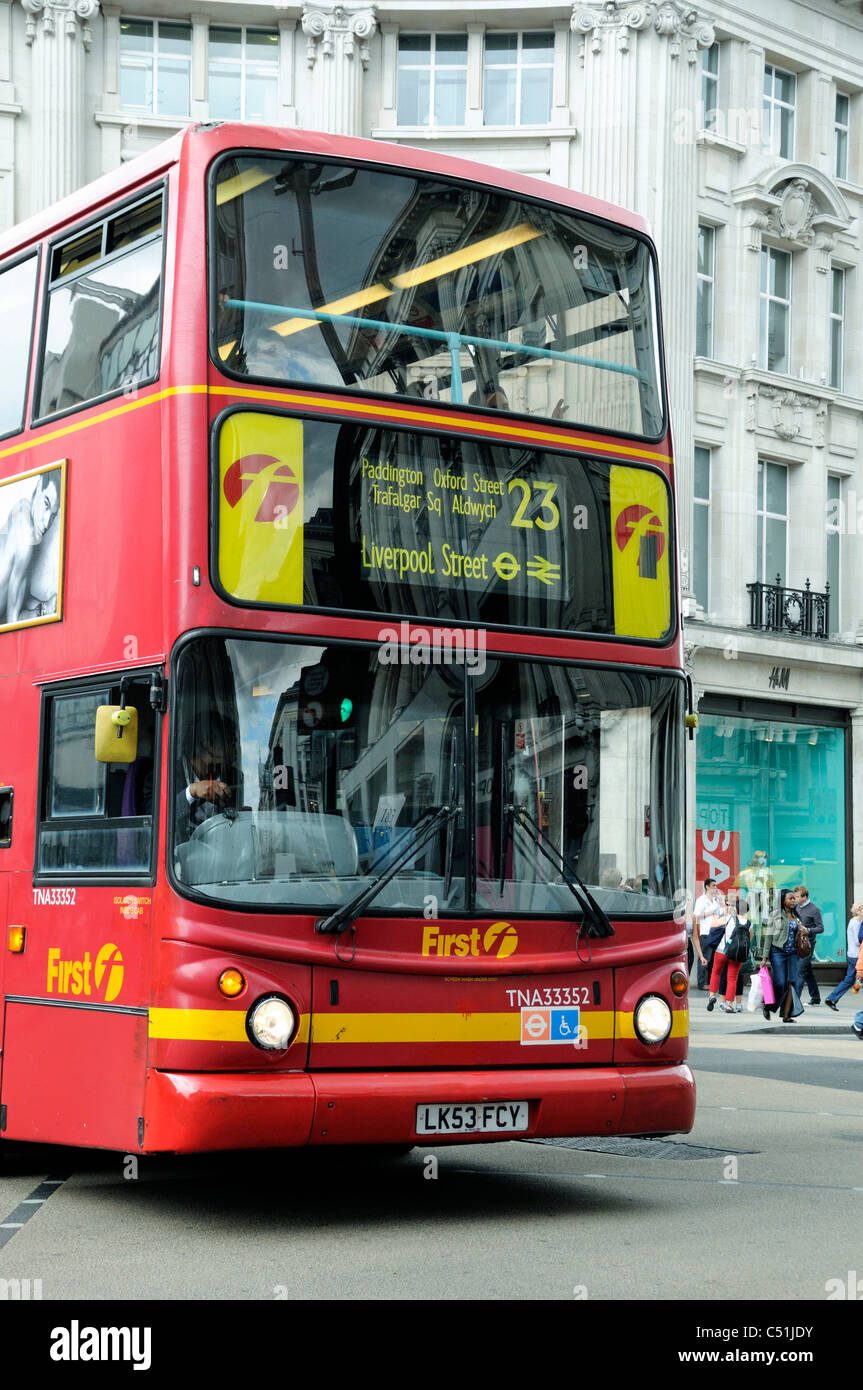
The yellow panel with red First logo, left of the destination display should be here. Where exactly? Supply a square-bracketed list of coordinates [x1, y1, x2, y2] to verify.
[218, 411, 303, 603]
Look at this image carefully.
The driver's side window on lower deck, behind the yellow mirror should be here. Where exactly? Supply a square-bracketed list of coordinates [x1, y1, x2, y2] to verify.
[36, 674, 157, 878]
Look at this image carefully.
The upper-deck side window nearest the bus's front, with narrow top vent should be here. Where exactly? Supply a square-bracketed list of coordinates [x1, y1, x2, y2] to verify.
[35, 189, 164, 420]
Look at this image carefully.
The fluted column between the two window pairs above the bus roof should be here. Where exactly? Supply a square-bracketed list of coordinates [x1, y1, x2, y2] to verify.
[303, 3, 377, 135]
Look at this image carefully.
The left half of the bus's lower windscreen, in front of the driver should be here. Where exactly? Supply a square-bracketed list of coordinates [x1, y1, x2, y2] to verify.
[174, 639, 464, 910]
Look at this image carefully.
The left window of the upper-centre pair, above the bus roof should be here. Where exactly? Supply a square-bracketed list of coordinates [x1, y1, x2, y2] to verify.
[397, 33, 467, 125]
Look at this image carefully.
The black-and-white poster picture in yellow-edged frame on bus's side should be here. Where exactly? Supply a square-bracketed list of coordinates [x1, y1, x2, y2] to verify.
[0, 468, 63, 627]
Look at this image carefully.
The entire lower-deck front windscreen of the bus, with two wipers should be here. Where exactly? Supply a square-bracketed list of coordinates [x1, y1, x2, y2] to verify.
[172, 630, 682, 916]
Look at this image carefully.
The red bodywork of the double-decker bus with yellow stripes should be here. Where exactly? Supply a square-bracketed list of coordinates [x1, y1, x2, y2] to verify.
[0, 125, 695, 1152]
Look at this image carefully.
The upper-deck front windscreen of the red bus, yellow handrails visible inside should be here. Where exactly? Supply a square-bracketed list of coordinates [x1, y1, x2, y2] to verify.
[211, 154, 663, 439]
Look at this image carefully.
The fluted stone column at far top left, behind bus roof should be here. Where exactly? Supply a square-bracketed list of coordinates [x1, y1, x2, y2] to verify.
[21, 0, 99, 211]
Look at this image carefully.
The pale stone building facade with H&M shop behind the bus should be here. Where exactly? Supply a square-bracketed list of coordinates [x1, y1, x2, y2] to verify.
[0, 0, 863, 958]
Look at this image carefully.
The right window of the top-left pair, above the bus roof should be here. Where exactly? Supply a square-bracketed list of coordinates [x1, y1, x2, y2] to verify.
[207, 25, 279, 124]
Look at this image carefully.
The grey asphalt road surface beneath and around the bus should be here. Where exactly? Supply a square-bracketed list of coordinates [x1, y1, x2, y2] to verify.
[0, 1034, 863, 1302]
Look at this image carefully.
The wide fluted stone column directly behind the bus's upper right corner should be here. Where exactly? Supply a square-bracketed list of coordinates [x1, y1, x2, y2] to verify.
[571, 0, 714, 597]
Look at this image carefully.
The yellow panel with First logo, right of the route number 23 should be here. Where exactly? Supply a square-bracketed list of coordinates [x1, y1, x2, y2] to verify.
[610, 464, 671, 637]
